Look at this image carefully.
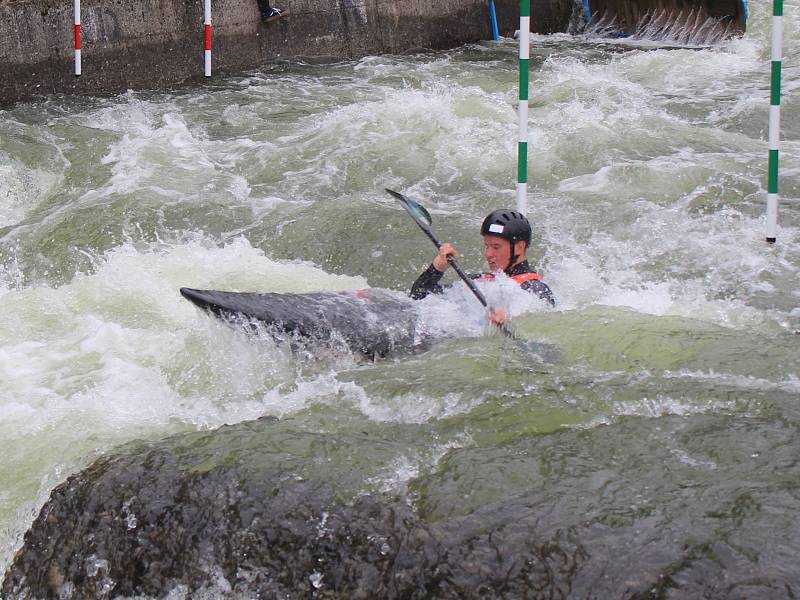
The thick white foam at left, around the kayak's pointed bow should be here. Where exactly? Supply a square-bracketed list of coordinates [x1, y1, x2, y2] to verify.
[0, 233, 365, 562]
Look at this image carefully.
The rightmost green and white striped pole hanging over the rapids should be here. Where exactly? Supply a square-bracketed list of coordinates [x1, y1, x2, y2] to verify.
[767, 0, 783, 244]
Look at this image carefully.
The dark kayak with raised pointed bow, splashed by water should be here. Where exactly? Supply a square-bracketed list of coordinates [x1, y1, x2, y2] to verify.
[180, 287, 427, 357]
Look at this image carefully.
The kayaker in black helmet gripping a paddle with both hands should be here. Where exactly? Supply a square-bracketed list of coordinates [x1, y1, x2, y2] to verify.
[411, 209, 555, 323]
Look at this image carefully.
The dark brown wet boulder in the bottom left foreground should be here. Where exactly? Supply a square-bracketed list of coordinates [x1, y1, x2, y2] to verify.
[2, 419, 580, 598]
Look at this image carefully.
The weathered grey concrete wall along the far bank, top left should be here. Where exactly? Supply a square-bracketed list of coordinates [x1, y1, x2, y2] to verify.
[0, 0, 566, 105]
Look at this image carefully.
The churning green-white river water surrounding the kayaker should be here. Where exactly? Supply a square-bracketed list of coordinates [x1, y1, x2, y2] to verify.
[0, 2, 800, 597]
